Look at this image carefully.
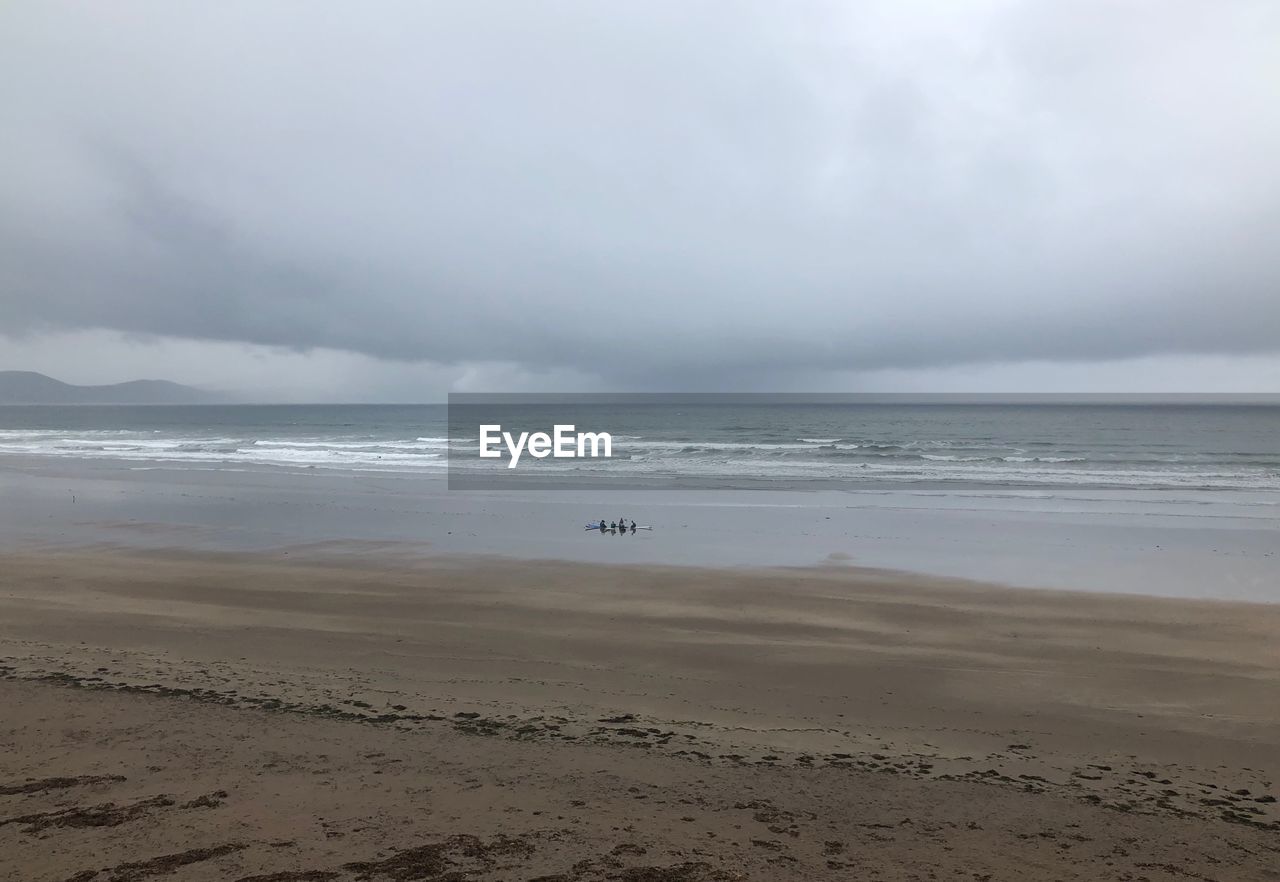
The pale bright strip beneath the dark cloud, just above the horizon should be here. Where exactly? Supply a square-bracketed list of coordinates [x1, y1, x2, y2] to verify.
[0, 330, 1280, 403]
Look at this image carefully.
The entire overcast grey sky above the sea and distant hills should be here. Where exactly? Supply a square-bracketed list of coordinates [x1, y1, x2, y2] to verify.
[0, 0, 1280, 401]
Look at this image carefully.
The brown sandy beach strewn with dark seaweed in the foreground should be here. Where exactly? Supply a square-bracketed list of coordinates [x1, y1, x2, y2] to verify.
[0, 545, 1280, 882]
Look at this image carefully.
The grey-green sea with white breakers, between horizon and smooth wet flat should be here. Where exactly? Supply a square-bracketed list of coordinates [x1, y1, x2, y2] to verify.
[0, 403, 1280, 496]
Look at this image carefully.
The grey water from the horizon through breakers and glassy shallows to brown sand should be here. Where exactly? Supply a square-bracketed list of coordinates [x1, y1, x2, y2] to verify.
[0, 397, 1280, 603]
